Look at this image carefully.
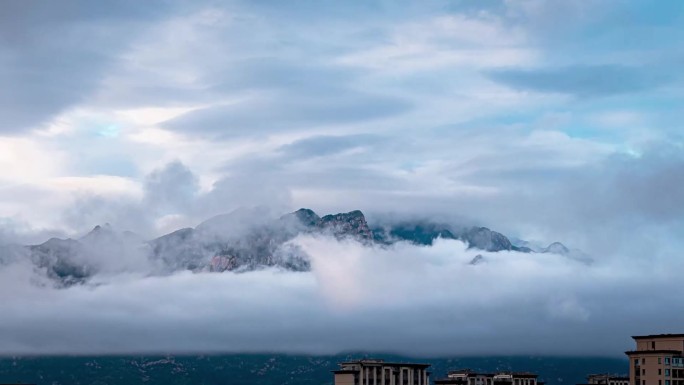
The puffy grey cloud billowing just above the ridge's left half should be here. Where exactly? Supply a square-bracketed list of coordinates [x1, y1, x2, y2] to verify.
[56, 160, 292, 236]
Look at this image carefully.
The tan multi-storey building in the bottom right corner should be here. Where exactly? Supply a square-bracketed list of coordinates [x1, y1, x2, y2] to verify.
[625, 334, 684, 385]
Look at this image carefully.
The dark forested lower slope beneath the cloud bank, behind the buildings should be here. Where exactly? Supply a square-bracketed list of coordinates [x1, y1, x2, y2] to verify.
[0, 352, 629, 385]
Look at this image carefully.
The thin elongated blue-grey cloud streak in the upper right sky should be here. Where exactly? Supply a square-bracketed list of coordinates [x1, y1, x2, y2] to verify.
[487, 65, 671, 97]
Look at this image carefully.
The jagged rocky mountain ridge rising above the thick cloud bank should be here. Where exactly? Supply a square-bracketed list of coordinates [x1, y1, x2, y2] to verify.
[6, 208, 587, 286]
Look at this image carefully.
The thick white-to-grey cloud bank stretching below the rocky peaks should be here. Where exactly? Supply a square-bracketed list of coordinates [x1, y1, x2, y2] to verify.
[0, 237, 684, 356]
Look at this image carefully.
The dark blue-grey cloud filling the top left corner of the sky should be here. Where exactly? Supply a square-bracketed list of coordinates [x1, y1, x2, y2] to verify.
[0, 0, 179, 133]
